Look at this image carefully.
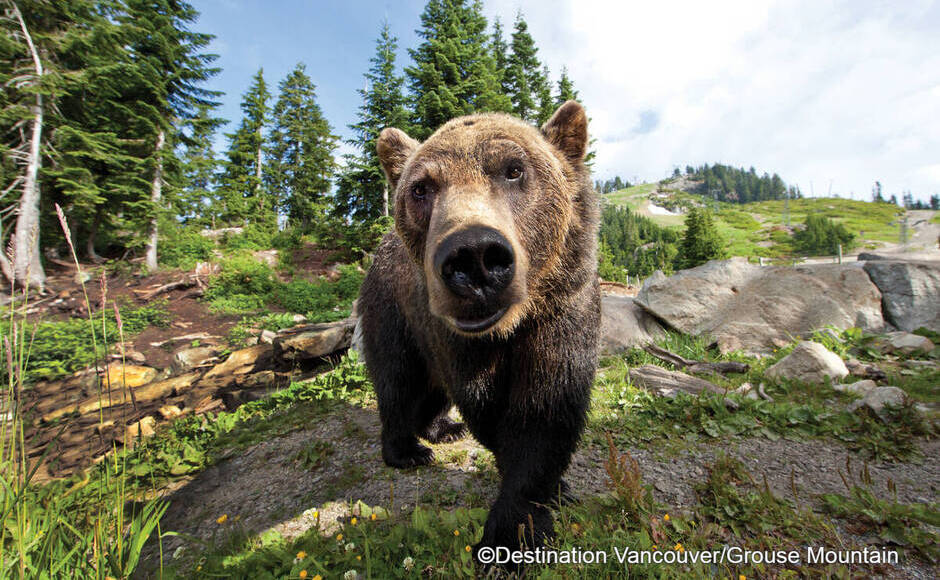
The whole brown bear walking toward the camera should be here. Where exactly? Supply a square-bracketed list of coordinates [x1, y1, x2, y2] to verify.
[358, 101, 600, 568]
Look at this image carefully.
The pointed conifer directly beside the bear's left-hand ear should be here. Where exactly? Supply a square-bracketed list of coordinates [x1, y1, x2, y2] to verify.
[334, 22, 408, 222]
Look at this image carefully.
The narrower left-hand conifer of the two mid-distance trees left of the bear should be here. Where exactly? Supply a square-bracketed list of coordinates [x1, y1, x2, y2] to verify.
[220, 69, 274, 225]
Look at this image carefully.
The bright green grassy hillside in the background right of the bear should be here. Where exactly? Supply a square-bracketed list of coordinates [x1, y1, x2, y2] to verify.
[603, 181, 912, 258]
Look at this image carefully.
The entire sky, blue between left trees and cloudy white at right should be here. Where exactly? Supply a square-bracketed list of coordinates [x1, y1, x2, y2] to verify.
[193, 0, 940, 199]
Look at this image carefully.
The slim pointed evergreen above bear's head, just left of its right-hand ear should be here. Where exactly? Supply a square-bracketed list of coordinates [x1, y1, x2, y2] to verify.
[506, 12, 551, 123]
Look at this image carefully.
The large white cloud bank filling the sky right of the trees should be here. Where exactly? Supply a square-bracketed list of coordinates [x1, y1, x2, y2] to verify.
[487, 0, 940, 199]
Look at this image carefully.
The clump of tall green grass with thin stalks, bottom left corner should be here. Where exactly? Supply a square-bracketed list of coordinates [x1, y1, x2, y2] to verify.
[0, 206, 168, 579]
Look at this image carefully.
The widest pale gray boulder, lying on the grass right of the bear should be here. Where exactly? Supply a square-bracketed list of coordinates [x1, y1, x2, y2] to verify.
[636, 258, 884, 354]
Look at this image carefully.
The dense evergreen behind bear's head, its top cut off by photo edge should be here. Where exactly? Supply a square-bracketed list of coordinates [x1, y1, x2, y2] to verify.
[405, 0, 510, 139]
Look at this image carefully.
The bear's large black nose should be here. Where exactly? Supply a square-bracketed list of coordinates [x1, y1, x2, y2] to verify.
[434, 226, 515, 301]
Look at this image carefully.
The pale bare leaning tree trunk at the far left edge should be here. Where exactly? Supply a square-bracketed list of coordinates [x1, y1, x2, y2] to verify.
[11, 3, 46, 290]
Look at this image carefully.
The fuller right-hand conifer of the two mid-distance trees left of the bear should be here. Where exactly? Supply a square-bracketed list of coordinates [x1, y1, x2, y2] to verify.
[259, 63, 338, 231]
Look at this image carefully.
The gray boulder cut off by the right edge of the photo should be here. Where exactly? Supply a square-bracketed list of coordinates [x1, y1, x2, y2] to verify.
[864, 260, 940, 332]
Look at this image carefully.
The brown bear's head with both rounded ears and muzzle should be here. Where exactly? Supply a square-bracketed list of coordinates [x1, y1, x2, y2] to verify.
[377, 101, 597, 336]
